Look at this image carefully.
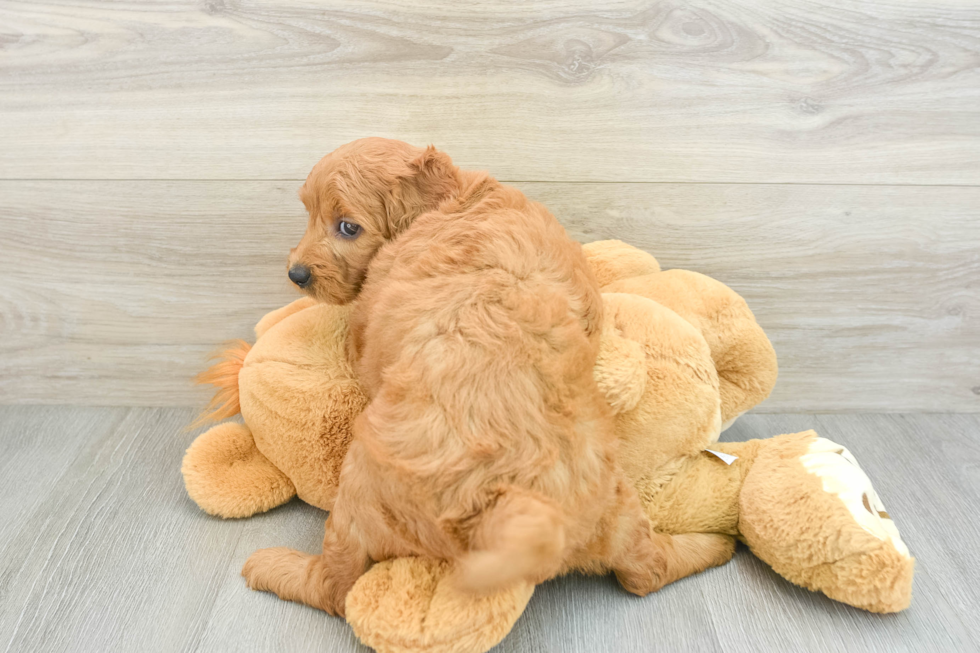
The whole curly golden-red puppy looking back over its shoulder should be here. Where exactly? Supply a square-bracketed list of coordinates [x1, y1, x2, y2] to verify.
[242, 138, 733, 615]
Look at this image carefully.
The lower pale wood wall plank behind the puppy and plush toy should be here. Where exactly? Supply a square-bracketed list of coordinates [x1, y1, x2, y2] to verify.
[0, 181, 980, 412]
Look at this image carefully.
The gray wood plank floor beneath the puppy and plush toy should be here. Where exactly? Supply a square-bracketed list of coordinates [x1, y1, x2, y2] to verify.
[0, 406, 980, 653]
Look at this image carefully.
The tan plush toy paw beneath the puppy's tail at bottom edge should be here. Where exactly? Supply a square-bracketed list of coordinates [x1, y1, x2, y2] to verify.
[346, 558, 534, 653]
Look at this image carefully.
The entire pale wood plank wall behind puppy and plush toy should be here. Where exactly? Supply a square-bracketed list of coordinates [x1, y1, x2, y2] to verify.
[0, 0, 980, 411]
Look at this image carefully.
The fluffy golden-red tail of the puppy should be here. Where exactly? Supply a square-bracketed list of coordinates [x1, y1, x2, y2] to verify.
[457, 487, 565, 594]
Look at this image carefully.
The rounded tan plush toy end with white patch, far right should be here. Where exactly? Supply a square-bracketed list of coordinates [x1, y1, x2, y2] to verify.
[739, 431, 915, 612]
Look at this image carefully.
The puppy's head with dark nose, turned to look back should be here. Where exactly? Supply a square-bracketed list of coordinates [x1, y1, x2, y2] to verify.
[287, 138, 459, 304]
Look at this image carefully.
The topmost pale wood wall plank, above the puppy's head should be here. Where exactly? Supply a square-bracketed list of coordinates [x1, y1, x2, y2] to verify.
[0, 0, 980, 184]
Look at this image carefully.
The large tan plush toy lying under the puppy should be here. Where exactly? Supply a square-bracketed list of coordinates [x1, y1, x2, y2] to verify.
[183, 241, 914, 653]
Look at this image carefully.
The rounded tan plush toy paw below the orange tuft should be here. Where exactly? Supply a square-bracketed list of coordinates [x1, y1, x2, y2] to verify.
[181, 422, 296, 518]
